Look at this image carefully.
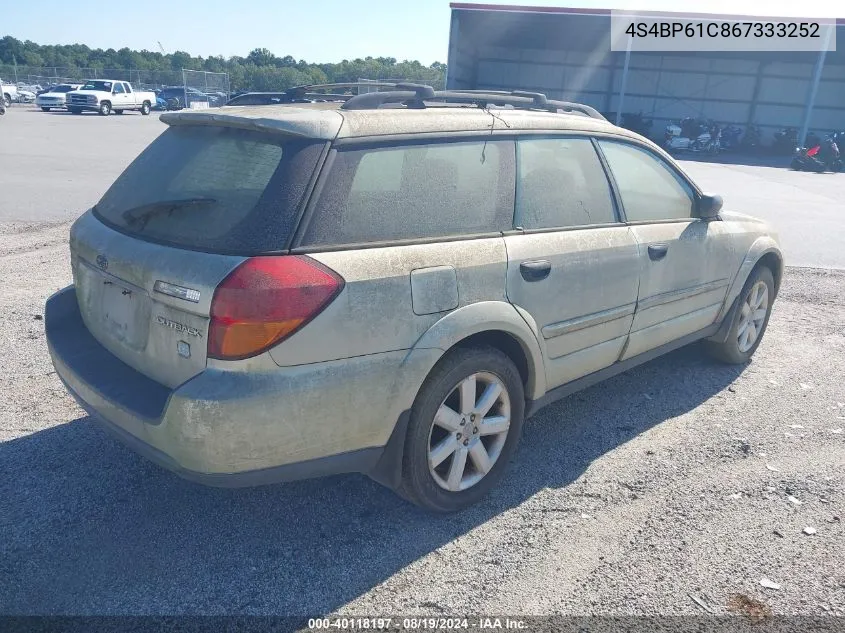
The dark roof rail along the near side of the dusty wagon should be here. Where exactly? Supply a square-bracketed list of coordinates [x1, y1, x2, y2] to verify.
[341, 84, 607, 121]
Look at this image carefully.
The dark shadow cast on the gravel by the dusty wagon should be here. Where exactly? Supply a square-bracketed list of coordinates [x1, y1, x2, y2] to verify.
[0, 346, 743, 617]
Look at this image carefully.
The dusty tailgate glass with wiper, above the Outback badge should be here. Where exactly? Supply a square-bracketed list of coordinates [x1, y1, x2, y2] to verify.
[94, 126, 323, 254]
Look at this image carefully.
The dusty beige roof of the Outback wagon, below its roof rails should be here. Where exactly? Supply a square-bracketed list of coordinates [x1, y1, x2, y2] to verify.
[161, 102, 636, 140]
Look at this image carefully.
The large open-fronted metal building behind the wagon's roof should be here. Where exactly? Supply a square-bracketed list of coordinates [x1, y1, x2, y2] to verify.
[447, 3, 845, 143]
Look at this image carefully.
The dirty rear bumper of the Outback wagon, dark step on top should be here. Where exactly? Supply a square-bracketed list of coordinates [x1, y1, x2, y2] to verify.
[45, 286, 427, 487]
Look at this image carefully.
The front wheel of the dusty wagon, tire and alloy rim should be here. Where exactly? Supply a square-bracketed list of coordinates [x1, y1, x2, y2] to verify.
[707, 266, 775, 365]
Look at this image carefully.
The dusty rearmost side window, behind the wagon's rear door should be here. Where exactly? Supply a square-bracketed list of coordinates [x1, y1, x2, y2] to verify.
[302, 140, 513, 246]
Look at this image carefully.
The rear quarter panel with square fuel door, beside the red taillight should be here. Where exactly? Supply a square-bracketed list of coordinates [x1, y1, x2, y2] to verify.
[270, 237, 507, 366]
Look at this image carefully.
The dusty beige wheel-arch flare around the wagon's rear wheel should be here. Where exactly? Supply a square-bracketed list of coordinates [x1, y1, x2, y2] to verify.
[411, 301, 546, 399]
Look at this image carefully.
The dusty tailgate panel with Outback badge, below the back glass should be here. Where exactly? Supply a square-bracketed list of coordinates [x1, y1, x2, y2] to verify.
[70, 211, 244, 388]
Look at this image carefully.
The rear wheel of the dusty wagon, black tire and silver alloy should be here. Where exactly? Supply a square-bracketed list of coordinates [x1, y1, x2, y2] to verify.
[397, 347, 525, 513]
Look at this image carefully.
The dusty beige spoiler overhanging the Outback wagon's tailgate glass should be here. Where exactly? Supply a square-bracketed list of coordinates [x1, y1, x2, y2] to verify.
[159, 106, 343, 141]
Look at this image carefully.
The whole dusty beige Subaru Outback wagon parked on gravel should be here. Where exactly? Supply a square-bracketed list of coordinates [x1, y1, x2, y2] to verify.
[45, 86, 783, 512]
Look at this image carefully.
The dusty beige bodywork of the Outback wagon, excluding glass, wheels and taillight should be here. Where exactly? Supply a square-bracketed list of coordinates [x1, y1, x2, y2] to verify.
[42, 106, 782, 483]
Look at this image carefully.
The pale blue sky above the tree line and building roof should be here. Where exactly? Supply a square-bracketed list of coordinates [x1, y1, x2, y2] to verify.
[0, 0, 845, 65]
